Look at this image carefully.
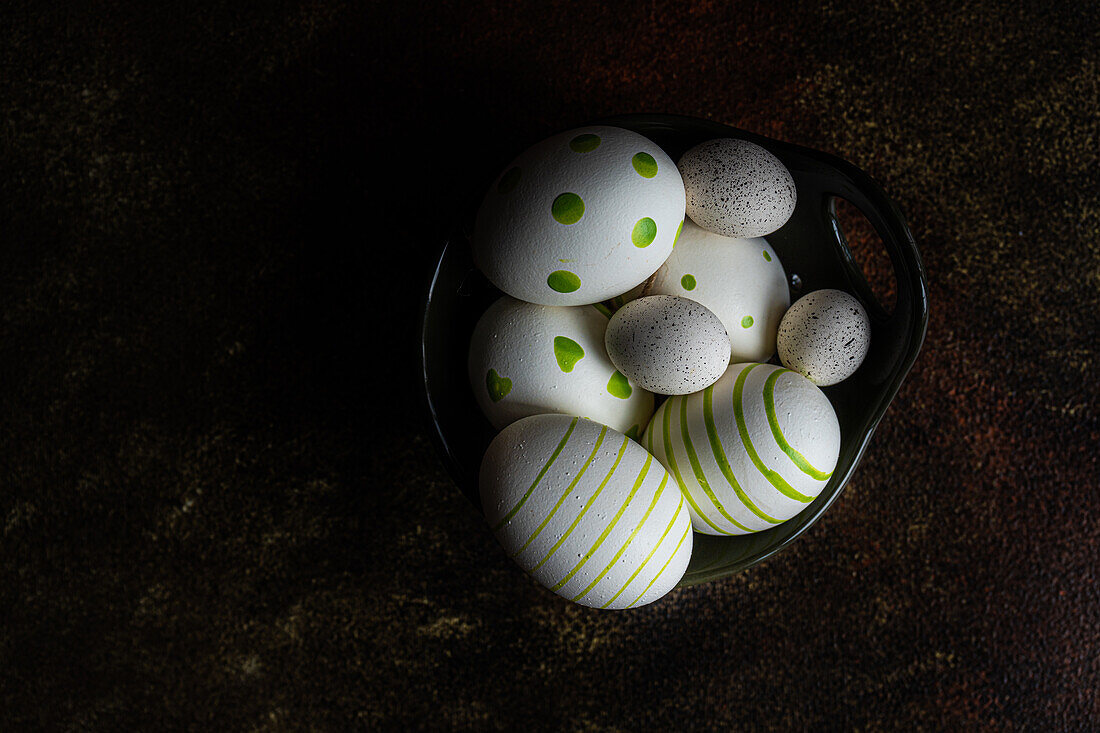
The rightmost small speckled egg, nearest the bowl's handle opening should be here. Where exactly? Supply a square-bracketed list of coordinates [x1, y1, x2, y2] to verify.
[779, 289, 871, 386]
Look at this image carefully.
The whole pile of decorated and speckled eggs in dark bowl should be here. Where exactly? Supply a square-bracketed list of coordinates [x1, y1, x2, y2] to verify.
[468, 125, 870, 609]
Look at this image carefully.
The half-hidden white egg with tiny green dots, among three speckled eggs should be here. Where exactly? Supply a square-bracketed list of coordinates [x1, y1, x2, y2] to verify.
[646, 221, 791, 362]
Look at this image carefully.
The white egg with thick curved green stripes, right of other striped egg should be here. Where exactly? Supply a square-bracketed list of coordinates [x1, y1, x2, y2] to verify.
[642, 363, 840, 535]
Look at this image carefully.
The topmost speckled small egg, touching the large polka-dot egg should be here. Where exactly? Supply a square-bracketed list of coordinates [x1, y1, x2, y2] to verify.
[679, 139, 798, 237]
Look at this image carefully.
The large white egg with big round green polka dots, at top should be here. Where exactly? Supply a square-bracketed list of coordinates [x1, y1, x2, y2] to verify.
[473, 125, 684, 305]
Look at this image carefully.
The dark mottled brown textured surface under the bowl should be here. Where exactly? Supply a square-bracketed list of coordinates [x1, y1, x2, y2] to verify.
[0, 0, 1100, 731]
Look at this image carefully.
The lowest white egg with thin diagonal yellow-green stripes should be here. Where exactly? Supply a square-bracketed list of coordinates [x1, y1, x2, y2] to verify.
[481, 415, 692, 609]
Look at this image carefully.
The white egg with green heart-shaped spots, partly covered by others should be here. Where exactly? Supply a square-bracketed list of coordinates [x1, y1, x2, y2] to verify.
[468, 296, 653, 438]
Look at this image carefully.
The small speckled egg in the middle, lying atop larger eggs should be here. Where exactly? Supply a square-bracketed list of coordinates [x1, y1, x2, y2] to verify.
[604, 295, 729, 394]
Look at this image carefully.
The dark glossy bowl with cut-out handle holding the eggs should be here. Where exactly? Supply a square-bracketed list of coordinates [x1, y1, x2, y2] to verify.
[421, 114, 928, 586]
